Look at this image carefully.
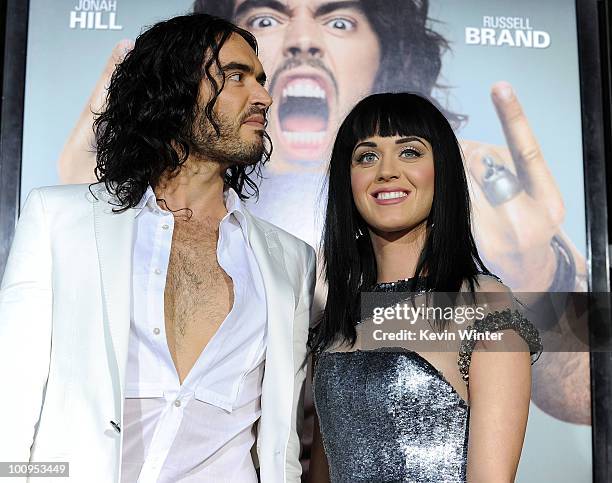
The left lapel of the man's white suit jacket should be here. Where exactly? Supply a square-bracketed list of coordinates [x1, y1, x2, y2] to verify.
[93, 185, 136, 391]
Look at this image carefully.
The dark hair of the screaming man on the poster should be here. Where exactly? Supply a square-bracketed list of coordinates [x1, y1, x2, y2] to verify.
[193, 0, 466, 128]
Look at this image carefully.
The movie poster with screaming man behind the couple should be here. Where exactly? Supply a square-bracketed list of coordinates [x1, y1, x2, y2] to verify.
[21, 0, 591, 483]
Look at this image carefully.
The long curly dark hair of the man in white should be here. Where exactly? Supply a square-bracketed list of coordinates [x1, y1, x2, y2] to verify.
[94, 14, 271, 211]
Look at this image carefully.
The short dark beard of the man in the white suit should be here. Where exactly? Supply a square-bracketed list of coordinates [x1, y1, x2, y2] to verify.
[190, 109, 265, 166]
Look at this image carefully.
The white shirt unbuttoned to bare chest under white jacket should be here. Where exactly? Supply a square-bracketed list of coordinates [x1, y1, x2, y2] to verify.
[122, 187, 267, 483]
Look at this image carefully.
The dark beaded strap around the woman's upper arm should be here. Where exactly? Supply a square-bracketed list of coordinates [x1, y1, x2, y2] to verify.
[457, 309, 542, 384]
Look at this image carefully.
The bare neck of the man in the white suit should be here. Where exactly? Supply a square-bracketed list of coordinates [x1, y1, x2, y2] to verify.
[154, 157, 226, 220]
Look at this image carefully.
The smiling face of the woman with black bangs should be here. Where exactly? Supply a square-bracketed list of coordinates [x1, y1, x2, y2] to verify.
[351, 136, 434, 235]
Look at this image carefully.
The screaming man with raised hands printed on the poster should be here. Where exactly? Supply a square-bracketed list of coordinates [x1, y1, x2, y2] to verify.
[59, 0, 590, 424]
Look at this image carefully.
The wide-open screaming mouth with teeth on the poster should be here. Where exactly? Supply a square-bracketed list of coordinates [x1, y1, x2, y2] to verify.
[277, 77, 330, 160]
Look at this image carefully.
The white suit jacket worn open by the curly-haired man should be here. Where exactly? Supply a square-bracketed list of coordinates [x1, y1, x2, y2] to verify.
[0, 184, 315, 483]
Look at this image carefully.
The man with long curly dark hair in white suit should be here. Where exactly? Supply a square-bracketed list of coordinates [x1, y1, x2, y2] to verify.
[0, 14, 314, 483]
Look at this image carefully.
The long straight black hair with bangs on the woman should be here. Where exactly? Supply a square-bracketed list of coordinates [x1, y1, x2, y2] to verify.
[312, 93, 489, 351]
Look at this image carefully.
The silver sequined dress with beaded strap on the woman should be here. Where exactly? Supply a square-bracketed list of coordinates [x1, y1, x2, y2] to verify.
[313, 278, 541, 483]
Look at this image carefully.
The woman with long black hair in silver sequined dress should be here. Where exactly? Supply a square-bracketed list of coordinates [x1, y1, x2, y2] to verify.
[310, 93, 541, 483]
